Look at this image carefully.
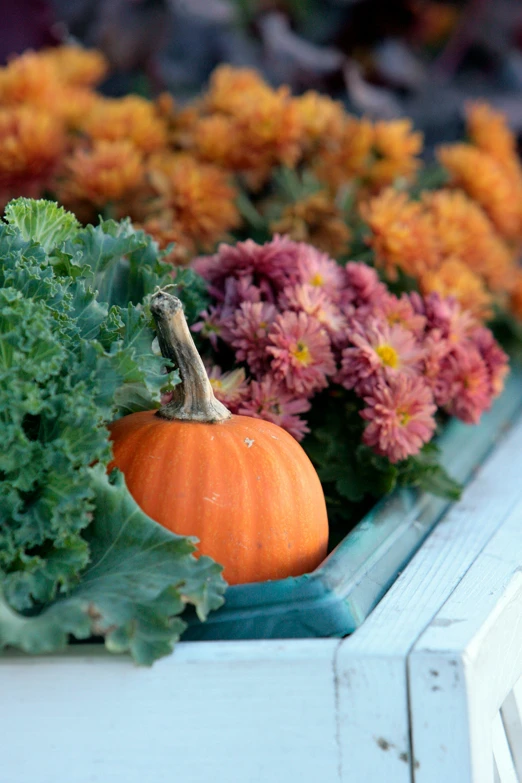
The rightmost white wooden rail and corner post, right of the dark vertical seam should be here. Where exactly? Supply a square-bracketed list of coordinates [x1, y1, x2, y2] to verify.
[408, 494, 522, 783]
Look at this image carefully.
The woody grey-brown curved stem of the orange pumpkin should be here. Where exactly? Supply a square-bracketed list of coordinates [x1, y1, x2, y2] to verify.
[150, 291, 232, 422]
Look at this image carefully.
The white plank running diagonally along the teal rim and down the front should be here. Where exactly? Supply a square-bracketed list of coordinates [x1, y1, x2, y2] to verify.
[337, 422, 522, 783]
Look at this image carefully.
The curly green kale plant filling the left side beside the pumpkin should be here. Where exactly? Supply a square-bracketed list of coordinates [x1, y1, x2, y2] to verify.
[0, 199, 222, 661]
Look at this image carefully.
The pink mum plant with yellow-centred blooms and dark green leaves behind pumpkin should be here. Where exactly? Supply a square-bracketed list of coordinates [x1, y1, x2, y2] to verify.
[189, 236, 508, 522]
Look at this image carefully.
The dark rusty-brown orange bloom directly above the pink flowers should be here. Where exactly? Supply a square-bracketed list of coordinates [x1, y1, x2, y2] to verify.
[270, 191, 350, 258]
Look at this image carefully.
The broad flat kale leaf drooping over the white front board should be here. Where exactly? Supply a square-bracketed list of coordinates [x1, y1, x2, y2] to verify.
[0, 468, 226, 665]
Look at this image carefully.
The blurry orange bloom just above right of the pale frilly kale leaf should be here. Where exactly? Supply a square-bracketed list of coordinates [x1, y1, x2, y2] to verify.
[57, 140, 144, 207]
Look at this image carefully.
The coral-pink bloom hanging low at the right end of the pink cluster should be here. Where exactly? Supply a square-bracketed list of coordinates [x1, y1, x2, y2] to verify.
[442, 344, 492, 424]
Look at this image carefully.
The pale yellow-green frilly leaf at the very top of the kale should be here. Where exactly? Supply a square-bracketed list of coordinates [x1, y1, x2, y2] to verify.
[5, 198, 80, 253]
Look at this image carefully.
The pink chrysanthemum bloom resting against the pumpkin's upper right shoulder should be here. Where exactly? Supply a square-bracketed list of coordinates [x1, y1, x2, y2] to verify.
[238, 377, 310, 440]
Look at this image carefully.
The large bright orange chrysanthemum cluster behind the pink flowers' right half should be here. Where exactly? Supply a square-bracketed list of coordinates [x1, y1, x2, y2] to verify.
[361, 189, 515, 317]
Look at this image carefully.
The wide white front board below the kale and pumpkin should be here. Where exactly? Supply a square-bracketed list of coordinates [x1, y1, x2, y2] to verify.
[0, 640, 340, 783]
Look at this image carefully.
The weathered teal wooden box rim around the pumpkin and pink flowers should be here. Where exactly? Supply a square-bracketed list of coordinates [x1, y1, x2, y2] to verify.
[183, 372, 522, 641]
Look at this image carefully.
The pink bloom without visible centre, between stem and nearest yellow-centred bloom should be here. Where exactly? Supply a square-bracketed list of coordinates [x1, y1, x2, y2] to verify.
[230, 302, 277, 372]
